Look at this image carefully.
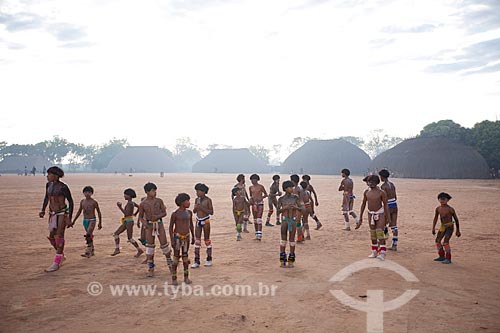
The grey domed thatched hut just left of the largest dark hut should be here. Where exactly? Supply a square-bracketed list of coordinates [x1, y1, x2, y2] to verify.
[281, 139, 371, 175]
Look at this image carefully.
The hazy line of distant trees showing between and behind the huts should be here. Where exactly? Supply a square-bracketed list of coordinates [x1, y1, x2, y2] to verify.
[0, 120, 500, 171]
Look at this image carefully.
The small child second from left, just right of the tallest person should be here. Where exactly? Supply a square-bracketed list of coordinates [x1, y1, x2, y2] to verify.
[73, 186, 102, 258]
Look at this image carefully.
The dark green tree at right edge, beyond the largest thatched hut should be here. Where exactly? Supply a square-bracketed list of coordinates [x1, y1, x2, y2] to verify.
[466, 120, 500, 170]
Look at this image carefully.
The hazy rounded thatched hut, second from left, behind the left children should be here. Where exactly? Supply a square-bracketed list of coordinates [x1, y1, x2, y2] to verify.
[105, 146, 175, 172]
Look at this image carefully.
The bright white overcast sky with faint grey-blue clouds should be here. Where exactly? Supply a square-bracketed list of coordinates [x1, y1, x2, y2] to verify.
[0, 0, 500, 148]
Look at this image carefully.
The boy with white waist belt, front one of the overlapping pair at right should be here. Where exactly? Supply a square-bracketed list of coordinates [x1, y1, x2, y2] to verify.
[356, 175, 390, 261]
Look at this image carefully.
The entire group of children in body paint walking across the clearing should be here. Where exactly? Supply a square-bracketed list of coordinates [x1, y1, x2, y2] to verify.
[39, 166, 461, 278]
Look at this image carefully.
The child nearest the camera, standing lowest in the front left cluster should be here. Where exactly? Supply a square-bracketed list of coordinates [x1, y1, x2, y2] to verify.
[168, 193, 194, 286]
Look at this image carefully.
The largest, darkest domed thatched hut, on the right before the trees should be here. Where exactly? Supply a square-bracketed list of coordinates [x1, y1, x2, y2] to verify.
[370, 137, 489, 179]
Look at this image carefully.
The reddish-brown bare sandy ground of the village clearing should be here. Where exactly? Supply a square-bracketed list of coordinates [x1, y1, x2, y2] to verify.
[0, 174, 500, 332]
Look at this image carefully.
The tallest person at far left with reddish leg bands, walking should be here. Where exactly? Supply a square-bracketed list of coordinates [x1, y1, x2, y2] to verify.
[38, 166, 73, 272]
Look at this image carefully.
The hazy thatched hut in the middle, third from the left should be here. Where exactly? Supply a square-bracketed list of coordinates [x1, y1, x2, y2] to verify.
[193, 148, 270, 173]
